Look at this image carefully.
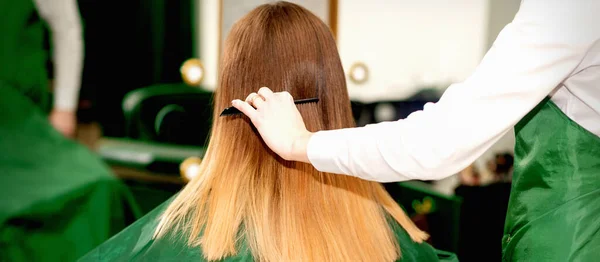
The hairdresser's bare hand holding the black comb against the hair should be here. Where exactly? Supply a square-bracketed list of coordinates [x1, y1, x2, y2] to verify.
[232, 87, 312, 163]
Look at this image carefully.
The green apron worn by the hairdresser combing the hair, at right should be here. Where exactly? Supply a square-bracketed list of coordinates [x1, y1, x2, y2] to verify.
[503, 100, 600, 261]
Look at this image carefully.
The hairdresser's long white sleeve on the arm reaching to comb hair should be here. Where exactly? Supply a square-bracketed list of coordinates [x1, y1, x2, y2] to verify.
[307, 0, 598, 182]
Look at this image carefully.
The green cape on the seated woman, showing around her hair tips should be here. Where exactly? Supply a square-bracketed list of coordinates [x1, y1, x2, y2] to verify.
[79, 200, 458, 262]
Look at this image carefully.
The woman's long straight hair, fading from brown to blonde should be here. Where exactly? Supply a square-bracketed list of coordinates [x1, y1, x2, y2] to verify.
[155, 2, 427, 261]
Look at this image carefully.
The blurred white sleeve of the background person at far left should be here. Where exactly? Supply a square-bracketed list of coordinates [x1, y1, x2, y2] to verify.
[35, 0, 83, 111]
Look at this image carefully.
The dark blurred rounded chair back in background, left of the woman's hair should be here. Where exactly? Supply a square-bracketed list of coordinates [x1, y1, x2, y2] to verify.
[123, 83, 213, 146]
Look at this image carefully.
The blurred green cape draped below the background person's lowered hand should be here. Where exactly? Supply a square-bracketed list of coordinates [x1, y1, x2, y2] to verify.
[0, 81, 139, 261]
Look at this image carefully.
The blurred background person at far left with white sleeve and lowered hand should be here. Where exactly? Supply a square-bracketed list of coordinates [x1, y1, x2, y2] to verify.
[0, 0, 83, 137]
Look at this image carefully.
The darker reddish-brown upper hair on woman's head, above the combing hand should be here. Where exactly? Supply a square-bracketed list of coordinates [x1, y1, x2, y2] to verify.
[214, 2, 353, 135]
